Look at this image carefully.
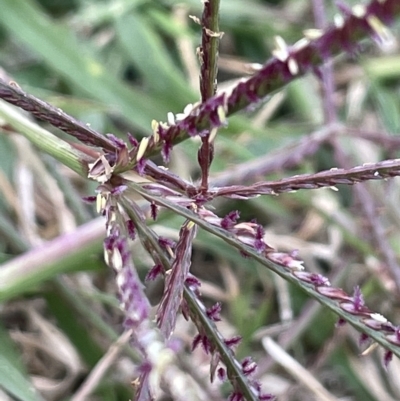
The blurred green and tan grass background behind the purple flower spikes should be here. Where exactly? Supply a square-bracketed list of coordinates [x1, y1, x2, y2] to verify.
[0, 0, 400, 401]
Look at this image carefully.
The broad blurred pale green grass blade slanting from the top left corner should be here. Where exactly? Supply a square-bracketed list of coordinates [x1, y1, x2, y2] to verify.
[0, 0, 169, 132]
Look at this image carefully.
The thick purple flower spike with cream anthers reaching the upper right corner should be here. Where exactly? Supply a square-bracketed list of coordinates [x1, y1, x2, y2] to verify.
[126, 0, 400, 171]
